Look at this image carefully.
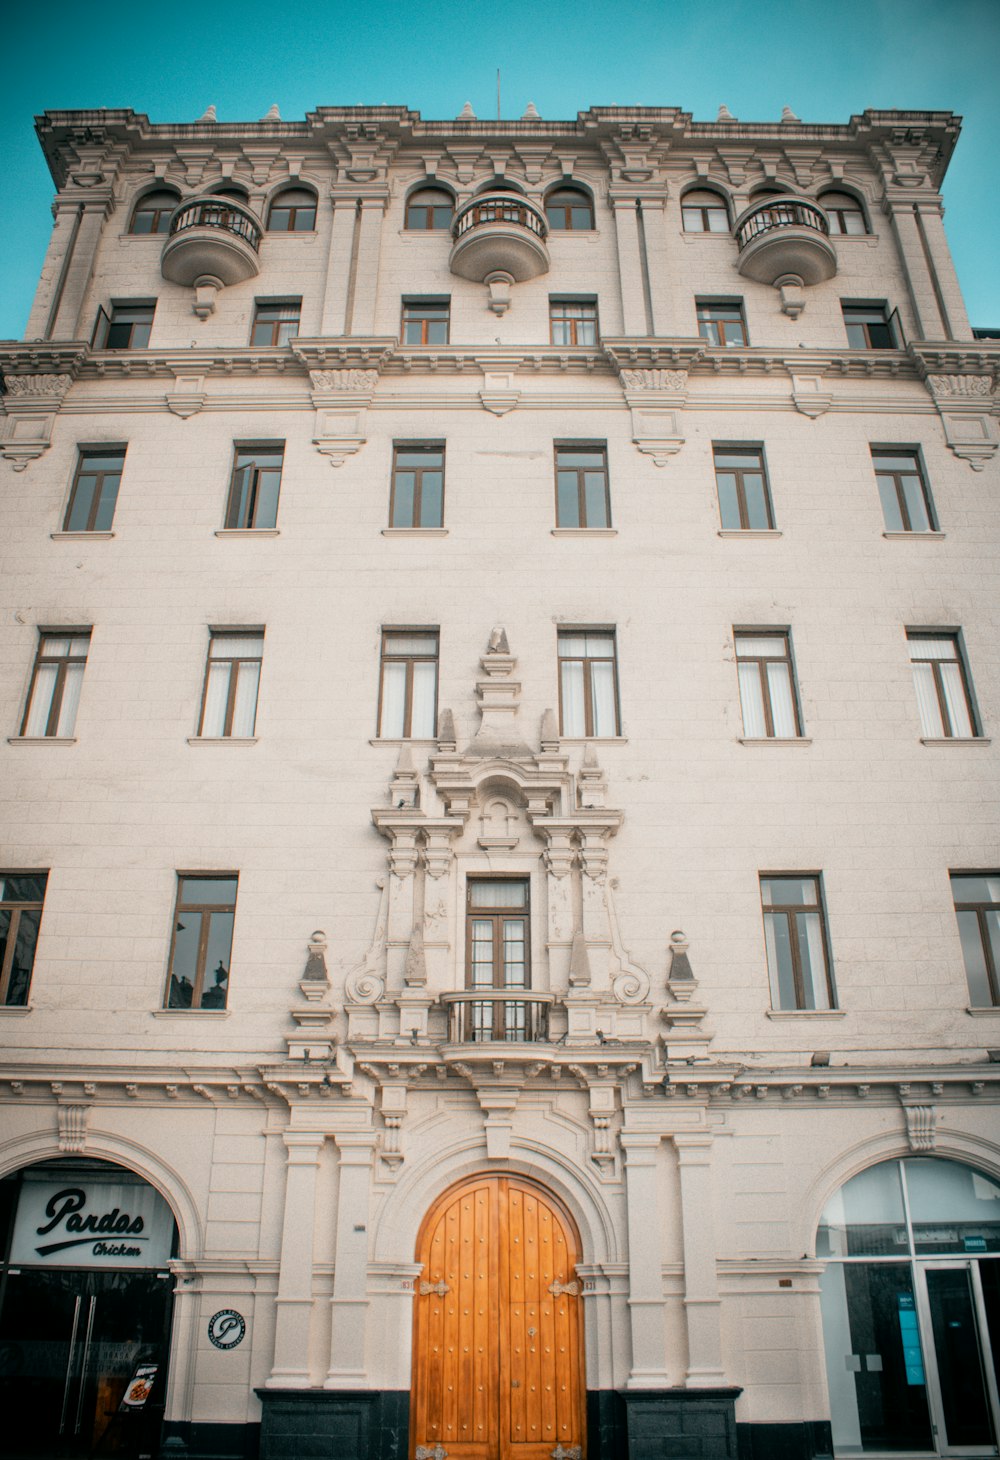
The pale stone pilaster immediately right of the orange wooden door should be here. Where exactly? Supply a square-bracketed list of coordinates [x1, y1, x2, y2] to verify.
[620, 1132, 670, 1388]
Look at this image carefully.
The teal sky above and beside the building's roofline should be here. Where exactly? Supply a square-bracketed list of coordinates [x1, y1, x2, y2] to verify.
[0, 0, 1000, 339]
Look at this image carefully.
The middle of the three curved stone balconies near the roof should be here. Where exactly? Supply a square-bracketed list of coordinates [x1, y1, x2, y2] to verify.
[448, 193, 549, 283]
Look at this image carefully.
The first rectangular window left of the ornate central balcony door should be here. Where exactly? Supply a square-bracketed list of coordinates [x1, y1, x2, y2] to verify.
[166, 872, 238, 1009]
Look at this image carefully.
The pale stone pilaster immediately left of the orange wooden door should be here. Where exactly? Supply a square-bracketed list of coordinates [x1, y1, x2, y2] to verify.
[323, 1130, 375, 1388]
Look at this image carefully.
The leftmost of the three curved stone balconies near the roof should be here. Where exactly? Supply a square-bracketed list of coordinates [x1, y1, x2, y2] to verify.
[159, 197, 261, 285]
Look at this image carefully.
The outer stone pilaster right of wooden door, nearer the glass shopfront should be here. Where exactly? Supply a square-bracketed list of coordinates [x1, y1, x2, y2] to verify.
[673, 1132, 726, 1388]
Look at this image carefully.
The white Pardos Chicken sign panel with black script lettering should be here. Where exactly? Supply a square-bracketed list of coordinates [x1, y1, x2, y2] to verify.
[10, 1171, 174, 1269]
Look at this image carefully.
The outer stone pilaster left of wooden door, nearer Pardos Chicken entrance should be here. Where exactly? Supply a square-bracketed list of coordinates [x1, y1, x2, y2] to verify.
[264, 1130, 326, 1388]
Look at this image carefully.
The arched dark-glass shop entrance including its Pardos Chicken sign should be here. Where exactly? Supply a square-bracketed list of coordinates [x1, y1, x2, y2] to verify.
[0, 1158, 177, 1460]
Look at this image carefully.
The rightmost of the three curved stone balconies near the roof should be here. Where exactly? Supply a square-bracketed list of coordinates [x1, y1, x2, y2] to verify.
[733, 196, 836, 285]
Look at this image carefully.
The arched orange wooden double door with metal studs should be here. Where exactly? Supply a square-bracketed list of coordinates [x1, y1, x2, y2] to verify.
[410, 1175, 585, 1460]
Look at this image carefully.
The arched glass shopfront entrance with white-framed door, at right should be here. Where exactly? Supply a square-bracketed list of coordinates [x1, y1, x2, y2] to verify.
[816, 1156, 1000, 1457]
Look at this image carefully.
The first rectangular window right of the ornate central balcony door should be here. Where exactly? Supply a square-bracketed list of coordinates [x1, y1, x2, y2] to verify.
[761, 873, 835, 1009]
